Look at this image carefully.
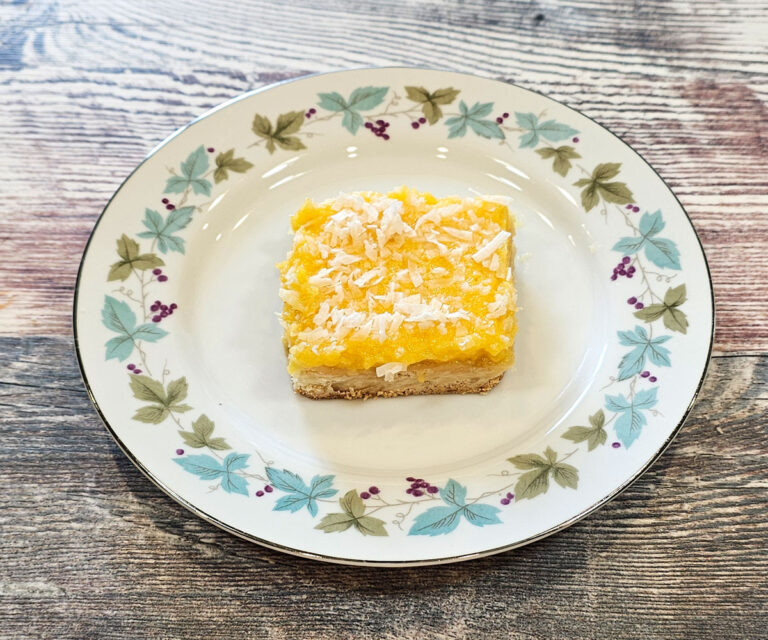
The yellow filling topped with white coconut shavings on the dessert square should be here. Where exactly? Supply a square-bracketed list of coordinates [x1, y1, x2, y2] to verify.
[278, 187, 516, 378]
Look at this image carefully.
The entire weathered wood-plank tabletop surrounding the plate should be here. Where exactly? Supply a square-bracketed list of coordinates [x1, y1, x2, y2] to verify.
[0, 0, 768, 639]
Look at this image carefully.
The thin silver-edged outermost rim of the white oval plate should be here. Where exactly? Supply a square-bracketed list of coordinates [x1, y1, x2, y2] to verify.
[72, 65, 716, 567]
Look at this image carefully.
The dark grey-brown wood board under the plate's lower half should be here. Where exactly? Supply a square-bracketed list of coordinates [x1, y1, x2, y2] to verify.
[0, 337, 768, 640]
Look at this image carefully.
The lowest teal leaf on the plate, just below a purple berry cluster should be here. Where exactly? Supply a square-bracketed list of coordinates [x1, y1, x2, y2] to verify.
[408, 480, 501, 536]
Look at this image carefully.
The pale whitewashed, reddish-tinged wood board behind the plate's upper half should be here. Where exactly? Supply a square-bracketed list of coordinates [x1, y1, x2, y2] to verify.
[0, 0, 768, 353]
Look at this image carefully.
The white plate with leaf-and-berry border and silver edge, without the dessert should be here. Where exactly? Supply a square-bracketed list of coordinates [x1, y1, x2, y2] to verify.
[75, 68, 713, 565]
